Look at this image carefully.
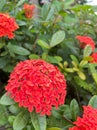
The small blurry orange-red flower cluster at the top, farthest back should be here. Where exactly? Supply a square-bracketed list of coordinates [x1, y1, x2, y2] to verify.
[23, 3, 35, 19]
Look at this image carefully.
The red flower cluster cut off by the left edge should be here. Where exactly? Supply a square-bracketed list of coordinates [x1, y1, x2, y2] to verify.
[0, 13, 19, 39]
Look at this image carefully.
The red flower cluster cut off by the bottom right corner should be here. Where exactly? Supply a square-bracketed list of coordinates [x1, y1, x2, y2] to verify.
[69, 106, 97, 130]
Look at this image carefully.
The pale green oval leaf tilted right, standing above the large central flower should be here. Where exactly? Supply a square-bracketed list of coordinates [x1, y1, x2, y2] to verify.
[50, 30, 65, 47]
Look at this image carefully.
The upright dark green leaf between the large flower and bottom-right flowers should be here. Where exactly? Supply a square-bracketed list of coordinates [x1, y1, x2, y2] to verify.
[70, 99, 79, 121]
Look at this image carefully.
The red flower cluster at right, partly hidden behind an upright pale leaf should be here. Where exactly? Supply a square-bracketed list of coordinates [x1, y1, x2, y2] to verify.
[76, 36, 95, 50]
